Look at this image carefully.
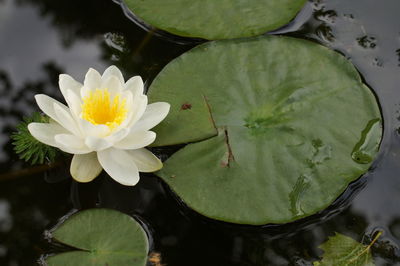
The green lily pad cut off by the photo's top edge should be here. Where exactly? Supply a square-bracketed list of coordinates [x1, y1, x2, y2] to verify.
[124, 0, 306, 40]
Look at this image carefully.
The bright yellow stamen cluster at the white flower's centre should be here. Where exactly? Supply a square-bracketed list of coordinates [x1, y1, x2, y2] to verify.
[82, 88, 128, 129]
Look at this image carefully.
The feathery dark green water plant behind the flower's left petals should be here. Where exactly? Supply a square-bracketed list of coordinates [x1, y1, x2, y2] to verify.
[11, 112, 59, 165]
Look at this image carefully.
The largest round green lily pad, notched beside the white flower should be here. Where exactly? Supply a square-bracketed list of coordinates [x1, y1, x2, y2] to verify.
[149, 36, 382, 225]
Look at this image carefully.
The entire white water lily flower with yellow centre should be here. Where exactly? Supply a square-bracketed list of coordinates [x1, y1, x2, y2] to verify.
[28, 66, 170, 186]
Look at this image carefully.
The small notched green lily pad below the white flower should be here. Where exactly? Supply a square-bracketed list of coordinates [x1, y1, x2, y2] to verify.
[46, 209, 149, 266]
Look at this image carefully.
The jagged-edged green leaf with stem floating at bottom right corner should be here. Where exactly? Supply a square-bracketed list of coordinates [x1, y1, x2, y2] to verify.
[314, 232, 382, 266]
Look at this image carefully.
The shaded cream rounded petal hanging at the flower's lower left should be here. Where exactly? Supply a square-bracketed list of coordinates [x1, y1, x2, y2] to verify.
[70, 152, 103, 183]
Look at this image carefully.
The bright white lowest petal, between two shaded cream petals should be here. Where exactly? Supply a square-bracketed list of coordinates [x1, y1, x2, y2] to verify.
[97, 148, 139, 186]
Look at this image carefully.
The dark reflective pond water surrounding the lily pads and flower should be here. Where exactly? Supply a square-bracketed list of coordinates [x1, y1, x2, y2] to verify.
[0, 0, 400, 266]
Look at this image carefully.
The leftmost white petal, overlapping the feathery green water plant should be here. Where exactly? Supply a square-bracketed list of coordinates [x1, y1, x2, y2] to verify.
[28, 123, 67, 147]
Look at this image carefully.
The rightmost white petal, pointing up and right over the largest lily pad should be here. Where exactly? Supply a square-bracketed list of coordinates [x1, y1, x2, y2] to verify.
[132, 102, 170, 131]
